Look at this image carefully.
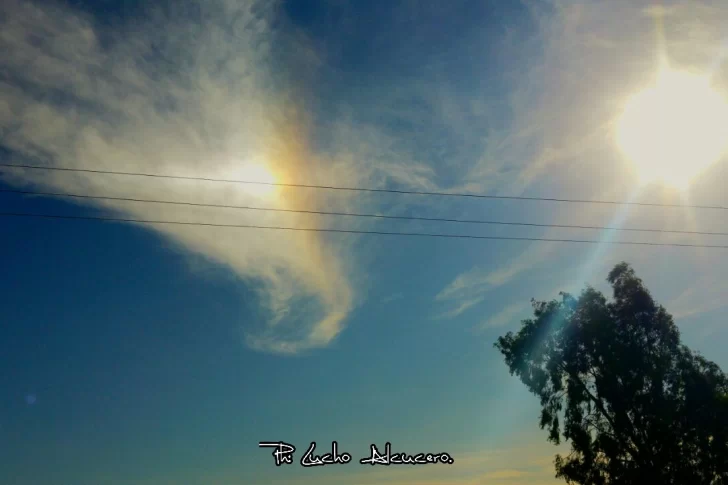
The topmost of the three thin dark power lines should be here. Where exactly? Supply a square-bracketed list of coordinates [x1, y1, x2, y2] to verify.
[0, 163, 728, 210]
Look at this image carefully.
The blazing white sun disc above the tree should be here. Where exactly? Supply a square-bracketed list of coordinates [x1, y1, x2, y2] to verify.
[617, 69, 728, 190]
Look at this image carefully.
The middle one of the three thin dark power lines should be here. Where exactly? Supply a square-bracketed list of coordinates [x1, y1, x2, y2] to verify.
[0, 189, 728, 236]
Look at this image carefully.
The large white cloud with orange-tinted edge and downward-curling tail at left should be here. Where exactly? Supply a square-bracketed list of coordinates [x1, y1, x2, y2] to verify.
[0, 0, 438, 354]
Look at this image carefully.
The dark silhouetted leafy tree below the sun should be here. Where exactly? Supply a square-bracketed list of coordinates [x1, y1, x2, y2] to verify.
[495, 263, 728, 485]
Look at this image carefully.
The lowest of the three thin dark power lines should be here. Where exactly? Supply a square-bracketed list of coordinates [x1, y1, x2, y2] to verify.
[5, 212, 728, 249]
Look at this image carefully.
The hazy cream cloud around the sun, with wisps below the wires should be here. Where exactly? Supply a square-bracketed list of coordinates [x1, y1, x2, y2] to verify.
[436, 0, 728, 326]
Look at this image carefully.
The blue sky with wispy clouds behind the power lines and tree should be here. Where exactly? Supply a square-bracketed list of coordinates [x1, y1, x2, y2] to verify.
[0, 0, 728, 485]
